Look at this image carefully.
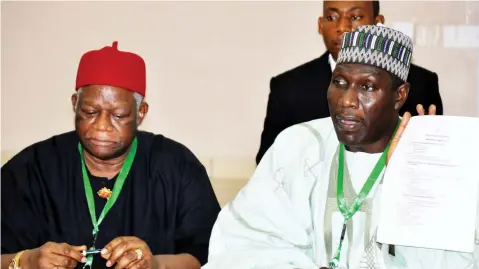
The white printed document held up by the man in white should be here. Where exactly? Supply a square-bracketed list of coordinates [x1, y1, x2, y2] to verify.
[377, 116, 479, 252]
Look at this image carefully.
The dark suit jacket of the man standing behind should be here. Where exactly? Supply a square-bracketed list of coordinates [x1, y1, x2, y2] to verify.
[256, 52, 443, 163]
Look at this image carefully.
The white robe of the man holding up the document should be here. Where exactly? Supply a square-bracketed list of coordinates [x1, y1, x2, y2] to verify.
[203, 118, 479, 269]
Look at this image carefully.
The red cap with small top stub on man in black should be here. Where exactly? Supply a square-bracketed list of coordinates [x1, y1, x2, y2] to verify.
[75, 41, 146, 96]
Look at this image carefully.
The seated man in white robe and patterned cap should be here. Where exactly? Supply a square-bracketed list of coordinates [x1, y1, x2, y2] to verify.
[203, 26, 475, 269]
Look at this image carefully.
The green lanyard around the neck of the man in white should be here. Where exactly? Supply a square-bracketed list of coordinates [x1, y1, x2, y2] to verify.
[329, 120, 401, 268]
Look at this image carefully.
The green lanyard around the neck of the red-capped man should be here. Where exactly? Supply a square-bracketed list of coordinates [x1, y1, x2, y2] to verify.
[78, 137, 138, 268]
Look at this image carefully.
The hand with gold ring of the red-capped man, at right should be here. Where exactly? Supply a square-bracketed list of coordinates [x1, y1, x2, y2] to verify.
[101, 236, 158, 269]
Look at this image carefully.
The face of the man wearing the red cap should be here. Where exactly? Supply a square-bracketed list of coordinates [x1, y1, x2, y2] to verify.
[72, 85, 146, 160]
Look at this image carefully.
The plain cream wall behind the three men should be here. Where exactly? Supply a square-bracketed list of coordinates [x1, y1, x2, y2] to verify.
[1, 1, 479, 205]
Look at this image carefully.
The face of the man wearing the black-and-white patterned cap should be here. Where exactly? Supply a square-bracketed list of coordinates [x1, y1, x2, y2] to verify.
[328, 64, 408, 149]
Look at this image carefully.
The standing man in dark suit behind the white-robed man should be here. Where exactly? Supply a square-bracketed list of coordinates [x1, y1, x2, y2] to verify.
[256, 1, 443, 164]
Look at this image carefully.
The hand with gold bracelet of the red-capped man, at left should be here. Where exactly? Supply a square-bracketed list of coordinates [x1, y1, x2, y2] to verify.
[20, 242, 87, 269]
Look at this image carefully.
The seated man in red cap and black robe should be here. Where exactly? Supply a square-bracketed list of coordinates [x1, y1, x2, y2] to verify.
[1, 42, 220, 269]
